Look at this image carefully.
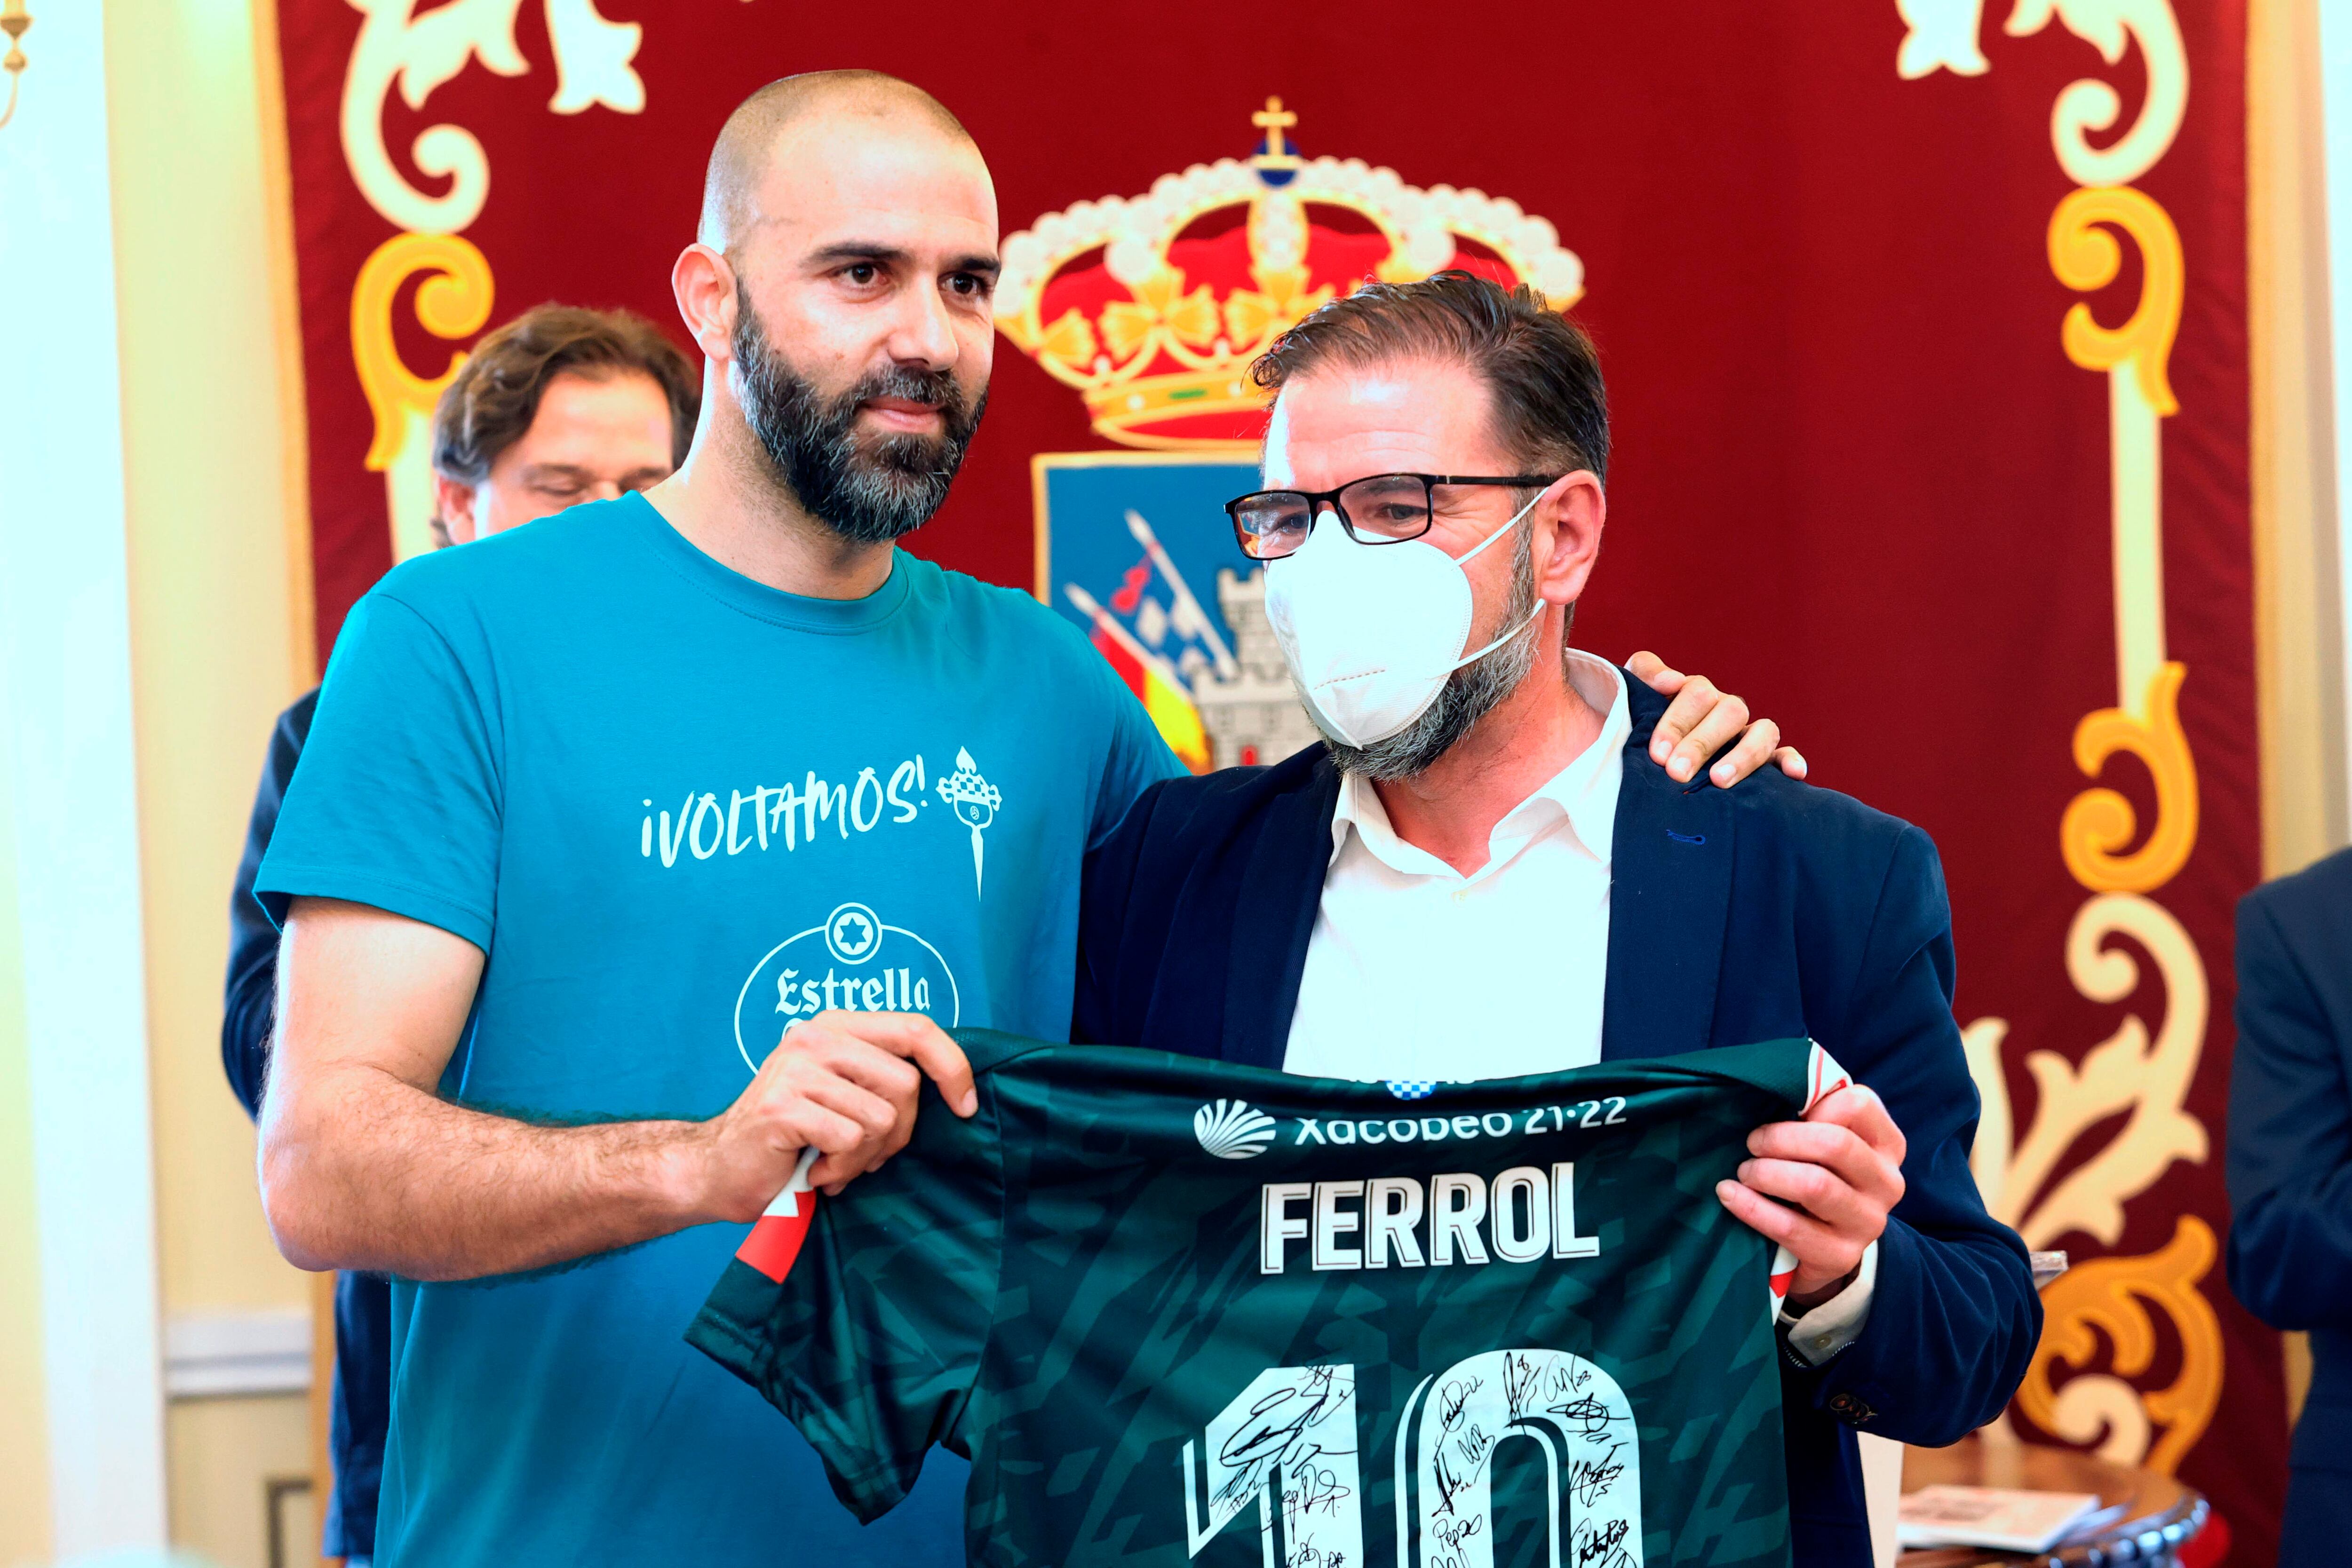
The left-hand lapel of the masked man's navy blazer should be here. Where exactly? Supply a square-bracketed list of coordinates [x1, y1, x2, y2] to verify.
[1218, 757, 1338, 1069]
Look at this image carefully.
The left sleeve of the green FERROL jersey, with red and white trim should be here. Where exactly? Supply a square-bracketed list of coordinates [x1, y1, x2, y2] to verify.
[687, 1074, 1004, 1523]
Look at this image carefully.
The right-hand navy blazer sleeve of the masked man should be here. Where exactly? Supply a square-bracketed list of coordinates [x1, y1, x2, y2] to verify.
[1783, 827, 2042, 1448]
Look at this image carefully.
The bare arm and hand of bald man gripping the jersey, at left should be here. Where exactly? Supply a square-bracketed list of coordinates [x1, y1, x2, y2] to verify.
[259, 898, 976, 1279]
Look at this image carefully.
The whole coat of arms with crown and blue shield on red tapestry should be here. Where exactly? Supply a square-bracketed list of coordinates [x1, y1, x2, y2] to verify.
[997, 99, 1583, 771]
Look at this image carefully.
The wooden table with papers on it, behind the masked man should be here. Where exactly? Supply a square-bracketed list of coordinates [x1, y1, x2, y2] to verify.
[1898, 1434, 2209, 1568]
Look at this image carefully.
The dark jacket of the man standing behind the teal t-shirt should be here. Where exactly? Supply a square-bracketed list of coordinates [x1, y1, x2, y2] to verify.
[221, 691, 393, 1559]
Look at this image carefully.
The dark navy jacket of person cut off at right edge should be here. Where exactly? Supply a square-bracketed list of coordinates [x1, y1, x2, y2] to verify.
[2230, 851, 2352, 1568]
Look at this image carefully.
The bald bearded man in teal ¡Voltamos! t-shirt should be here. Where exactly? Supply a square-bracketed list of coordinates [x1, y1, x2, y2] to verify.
[256, 73, 1771, 1568]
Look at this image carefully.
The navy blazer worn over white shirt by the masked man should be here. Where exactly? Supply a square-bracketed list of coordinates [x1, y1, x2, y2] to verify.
[1073, 677, 2042, 1568]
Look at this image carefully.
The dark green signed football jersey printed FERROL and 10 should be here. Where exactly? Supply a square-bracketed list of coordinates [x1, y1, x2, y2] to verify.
[687, 1029, 1846, 1568]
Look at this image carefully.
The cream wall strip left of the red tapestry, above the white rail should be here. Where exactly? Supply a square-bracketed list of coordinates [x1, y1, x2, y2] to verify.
[106, 0, 308, 1312]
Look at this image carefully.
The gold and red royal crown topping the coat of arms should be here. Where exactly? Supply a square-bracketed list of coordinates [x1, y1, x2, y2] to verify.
[997, 99, 1585, 449]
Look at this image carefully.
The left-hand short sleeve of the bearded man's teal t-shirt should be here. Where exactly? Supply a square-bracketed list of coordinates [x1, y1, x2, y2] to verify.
[254, 588, 503, 952]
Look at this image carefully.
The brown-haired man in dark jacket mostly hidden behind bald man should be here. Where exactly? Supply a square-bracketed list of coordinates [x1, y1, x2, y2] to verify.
[221, 306, 701, 1568]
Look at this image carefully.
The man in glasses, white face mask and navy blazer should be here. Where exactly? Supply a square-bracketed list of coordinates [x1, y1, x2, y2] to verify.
[1073, 273, 2042, 1568]
